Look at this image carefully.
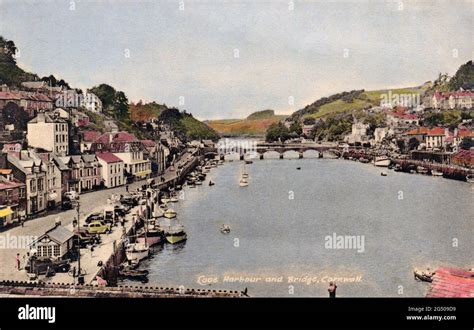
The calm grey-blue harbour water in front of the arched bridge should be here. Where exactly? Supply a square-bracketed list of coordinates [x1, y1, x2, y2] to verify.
[124, 153, 474, 297]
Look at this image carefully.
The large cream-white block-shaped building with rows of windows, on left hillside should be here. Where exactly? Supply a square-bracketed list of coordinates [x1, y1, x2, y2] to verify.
[27, 112, 69, 156]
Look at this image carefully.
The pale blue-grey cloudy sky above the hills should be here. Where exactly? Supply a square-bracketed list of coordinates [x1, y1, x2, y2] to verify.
[0, 0, 474, 119]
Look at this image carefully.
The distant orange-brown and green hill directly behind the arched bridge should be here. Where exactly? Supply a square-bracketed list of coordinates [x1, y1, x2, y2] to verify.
[207, 110, 287, 136]
